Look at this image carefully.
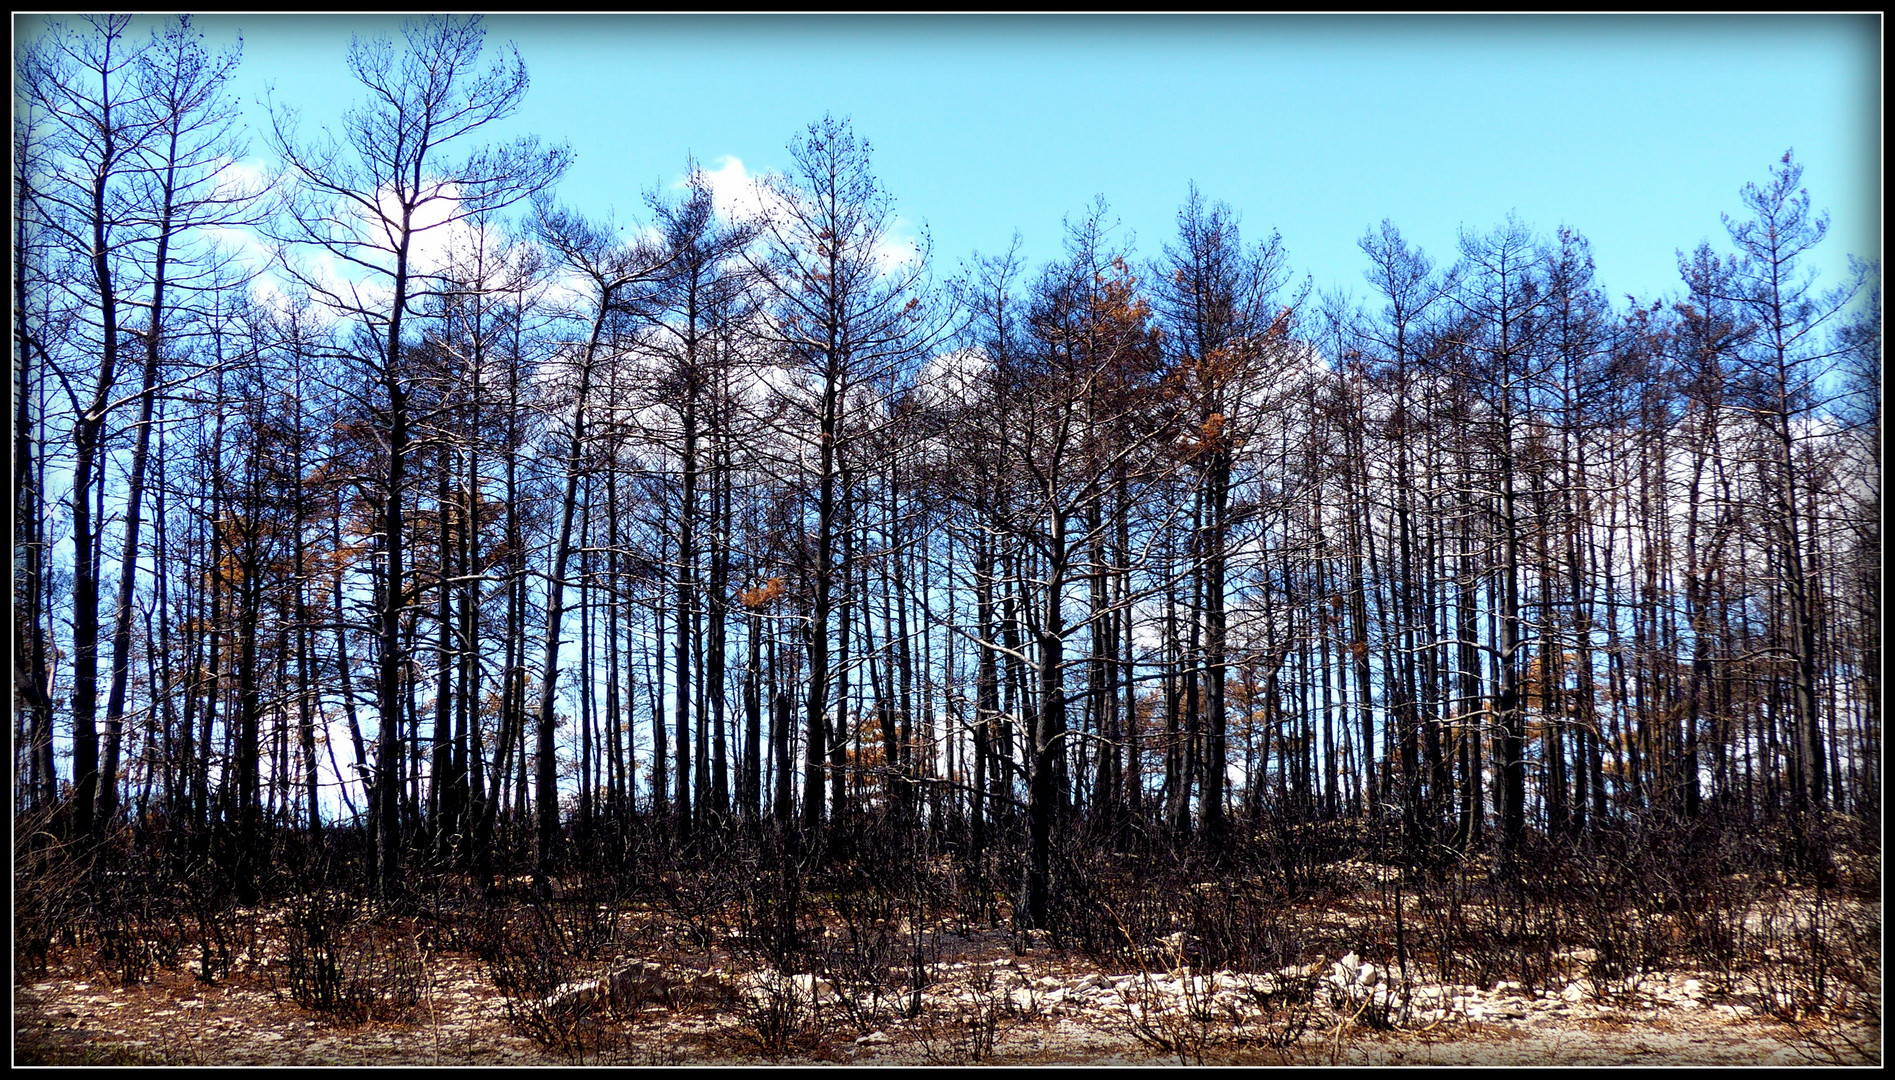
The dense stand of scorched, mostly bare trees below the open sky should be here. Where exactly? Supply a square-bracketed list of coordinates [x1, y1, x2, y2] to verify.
[13, 17, 1882, 913]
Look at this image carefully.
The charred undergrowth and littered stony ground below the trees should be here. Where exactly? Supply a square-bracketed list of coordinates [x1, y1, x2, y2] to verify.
[15, 807, 1882, 1065]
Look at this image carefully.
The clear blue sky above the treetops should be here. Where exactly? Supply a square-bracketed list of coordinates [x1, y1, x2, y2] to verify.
[19, 15, 1882, 306]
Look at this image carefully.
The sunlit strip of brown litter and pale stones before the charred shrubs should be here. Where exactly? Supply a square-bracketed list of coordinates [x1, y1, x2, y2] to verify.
[13, 879, 1882, 1065]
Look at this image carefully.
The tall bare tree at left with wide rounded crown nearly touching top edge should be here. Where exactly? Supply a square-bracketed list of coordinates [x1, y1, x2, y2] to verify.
[271, 17, 570, 891]
